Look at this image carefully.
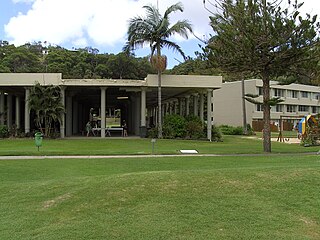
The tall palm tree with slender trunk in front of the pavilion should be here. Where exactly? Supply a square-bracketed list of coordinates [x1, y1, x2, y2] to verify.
[124, 2, 192, 138]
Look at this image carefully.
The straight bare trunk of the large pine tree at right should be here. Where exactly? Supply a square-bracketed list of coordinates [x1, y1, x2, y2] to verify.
[262, 73, 271, 152]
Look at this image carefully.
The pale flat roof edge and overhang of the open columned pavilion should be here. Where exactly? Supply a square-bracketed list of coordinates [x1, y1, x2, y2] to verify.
[0, 73, 222, 105]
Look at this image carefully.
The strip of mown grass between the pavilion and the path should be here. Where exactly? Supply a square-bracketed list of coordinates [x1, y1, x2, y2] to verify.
[0, 136, 319, 156]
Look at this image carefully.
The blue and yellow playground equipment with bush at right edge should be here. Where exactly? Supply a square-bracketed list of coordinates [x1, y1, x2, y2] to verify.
[298, 115, 320, 146]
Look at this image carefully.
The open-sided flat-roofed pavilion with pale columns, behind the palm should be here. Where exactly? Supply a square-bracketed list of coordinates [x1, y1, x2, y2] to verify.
[0, 73, 222, 140]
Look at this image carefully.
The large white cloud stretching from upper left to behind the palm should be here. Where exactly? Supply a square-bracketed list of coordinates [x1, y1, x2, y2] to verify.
[5, 0, 210, 47]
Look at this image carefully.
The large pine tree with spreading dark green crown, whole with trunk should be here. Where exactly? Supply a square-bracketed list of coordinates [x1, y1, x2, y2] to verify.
[209, 0, 319, 152]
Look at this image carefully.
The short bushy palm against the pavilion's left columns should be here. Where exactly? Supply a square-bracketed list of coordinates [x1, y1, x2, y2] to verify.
[28, 83, 64, 136]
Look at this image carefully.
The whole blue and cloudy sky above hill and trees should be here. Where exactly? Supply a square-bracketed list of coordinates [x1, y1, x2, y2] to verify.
[0, 0, 320, 68]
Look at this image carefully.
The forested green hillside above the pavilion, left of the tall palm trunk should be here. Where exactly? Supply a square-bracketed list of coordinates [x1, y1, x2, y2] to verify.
[0, 41, 155, 79]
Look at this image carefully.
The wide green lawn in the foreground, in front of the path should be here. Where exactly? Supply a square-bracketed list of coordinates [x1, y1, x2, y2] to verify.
[0, 155, 320, 240]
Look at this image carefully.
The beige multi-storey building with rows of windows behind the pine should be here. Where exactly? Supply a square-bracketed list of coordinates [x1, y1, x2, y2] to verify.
[213, 79, 320, 130]
